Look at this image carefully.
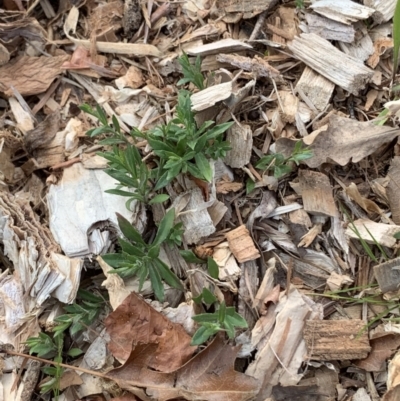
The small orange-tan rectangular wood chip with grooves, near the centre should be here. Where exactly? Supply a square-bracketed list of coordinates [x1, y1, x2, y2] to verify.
[225, 224, 260, 263]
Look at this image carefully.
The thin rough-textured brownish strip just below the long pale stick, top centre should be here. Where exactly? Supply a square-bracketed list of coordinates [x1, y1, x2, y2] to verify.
[217, 54, 280, 78]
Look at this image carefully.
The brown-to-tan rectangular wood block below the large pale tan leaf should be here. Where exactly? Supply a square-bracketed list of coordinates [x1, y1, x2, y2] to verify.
[299, 170, 338, 217]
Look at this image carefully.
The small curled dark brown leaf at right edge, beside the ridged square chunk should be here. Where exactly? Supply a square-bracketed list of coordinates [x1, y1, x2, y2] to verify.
[356, 332, 400, 372]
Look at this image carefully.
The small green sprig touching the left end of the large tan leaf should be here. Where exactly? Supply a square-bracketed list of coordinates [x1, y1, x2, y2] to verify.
[256, 141, 313, 178]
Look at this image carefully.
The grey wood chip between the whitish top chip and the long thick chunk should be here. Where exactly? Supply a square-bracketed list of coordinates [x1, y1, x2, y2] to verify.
[305, 14, 355, 43]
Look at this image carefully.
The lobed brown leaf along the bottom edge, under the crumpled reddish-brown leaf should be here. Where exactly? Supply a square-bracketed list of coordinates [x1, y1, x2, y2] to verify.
[107, 336, 259, 401]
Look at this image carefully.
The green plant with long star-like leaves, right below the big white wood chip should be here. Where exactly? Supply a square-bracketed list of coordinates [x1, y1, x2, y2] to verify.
[103, 209, 183, 302]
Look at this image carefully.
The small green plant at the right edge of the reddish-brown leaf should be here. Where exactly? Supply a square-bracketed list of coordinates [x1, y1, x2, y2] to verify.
[191, 288, 248, 345]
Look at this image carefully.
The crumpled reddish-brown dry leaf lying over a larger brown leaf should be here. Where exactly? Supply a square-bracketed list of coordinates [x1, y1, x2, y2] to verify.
[104, 293, 196, 372]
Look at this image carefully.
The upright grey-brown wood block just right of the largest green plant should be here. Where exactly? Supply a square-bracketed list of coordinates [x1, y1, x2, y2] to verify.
[224, 124, 253, 168]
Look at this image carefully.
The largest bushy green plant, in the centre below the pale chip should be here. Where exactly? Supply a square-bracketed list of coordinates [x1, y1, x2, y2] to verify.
[144, 90, 233, 190]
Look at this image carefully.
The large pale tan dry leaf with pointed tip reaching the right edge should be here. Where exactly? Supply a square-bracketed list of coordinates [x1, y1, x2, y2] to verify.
[276, 114, 400, 168]
